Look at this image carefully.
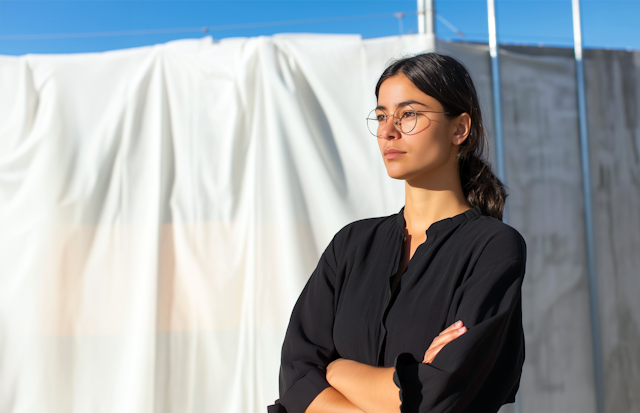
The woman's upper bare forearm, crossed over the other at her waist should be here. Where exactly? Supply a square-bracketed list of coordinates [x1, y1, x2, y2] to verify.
[327, 359, 400, 413]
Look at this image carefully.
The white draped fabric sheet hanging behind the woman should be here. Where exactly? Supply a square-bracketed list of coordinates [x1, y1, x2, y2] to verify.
[0, 35, 433, 413]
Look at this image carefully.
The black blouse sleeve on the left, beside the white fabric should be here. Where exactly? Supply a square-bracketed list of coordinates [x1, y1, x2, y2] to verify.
[270, 237, 337, 413]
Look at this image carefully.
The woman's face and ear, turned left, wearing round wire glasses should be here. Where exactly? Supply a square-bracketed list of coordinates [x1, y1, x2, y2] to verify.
[378, 74, 471, 181]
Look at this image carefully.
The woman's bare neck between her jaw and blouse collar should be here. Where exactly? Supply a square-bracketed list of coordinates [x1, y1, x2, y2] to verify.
[404, 168, 470, 234]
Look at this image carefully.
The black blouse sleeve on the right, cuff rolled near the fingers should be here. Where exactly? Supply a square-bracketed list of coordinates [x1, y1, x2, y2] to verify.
[394, 236, 526, 413]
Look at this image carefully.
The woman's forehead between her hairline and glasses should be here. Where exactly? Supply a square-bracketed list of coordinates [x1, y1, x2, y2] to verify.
[378, 73, 442, 110]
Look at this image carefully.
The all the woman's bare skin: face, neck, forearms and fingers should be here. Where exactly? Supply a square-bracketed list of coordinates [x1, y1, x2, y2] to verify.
[306, 74, 471, 413]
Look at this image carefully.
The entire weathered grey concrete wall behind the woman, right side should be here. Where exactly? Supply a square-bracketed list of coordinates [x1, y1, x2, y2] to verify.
[438, 42, 640, 413]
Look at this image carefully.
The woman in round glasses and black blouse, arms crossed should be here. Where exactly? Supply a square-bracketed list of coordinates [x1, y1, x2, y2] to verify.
[270, 53, 526, 413]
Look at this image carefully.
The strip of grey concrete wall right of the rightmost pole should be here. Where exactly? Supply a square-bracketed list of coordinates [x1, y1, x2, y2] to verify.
[585, 50, 640, 412]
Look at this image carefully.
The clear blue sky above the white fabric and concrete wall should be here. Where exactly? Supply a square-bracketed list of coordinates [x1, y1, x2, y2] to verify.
[0, 0, 640, 55]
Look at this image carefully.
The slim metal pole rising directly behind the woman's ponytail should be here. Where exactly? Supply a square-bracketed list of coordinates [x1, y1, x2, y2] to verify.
[487, 0, 508, 223]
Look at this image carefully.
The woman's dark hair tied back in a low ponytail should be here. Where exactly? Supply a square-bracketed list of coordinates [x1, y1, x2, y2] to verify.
[376, 53, 508, 220]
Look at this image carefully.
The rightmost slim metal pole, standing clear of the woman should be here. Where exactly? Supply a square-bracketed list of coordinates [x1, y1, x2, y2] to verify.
[572, 0, 604, 413]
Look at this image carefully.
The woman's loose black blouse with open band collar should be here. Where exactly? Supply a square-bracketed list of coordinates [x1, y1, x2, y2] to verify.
[269, 207, 526, 413]
